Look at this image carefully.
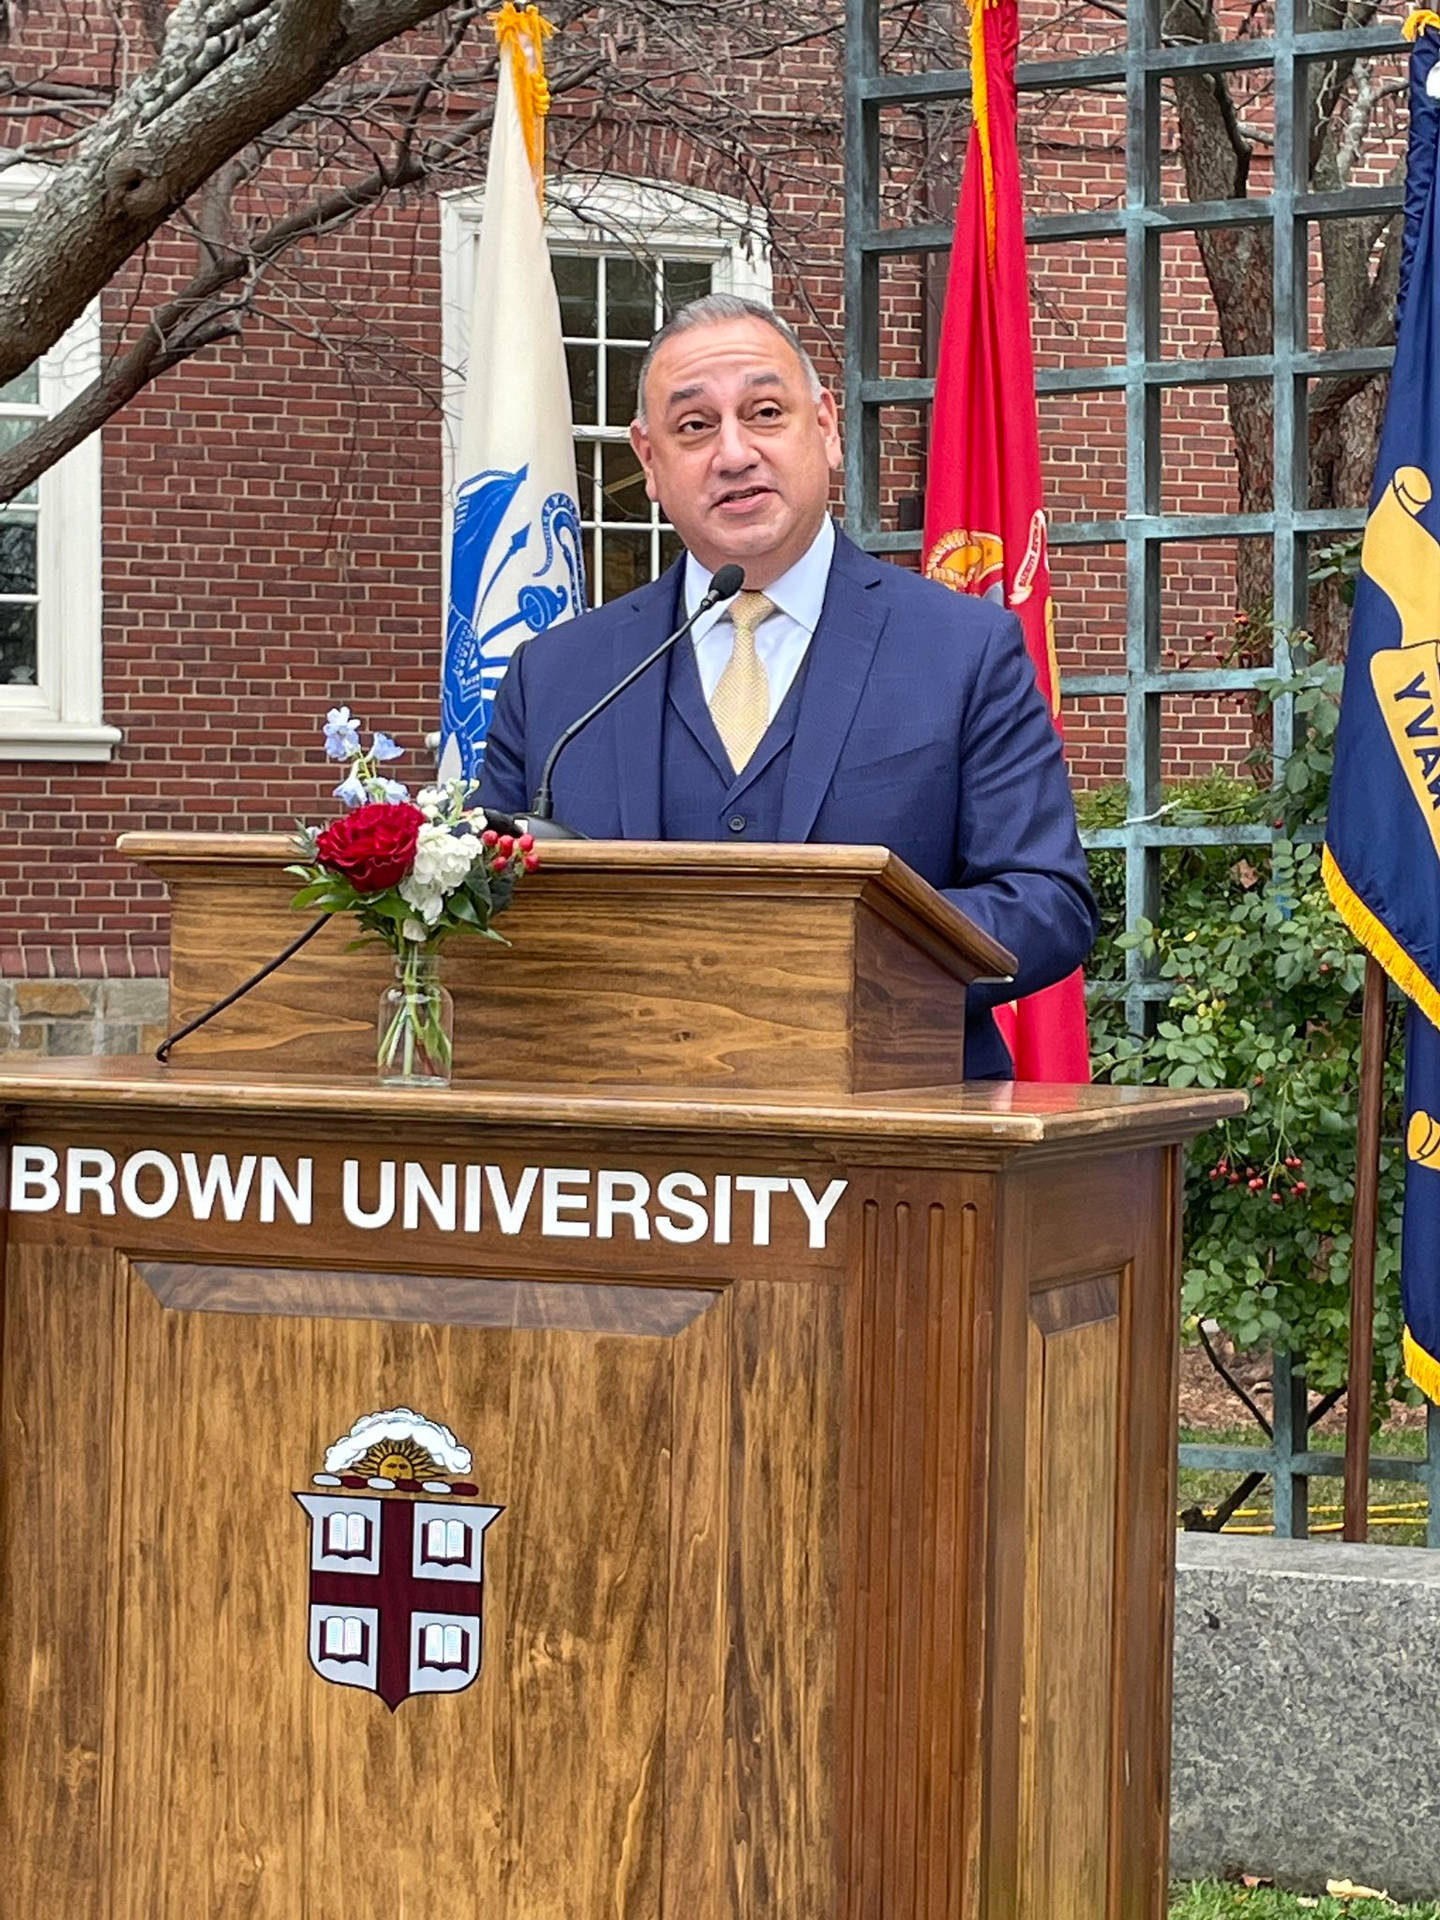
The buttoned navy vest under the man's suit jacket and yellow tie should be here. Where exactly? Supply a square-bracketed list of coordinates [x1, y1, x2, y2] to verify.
[660, 641, 810, 841]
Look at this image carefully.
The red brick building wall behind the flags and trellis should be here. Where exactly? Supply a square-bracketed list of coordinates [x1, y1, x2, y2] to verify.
[0, 0, 1397, 1050]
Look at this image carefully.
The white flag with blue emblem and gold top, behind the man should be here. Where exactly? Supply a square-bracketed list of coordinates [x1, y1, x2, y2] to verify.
[440, 4, 586, 778]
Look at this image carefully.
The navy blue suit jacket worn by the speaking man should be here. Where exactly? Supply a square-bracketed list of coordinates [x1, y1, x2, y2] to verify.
[480, 534, 1096, 1077]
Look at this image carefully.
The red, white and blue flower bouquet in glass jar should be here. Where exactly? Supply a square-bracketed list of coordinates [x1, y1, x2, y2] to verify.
[286, 707, 540, 1087]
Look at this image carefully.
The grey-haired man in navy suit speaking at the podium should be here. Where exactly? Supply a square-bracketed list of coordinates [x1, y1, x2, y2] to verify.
[480, 294, 1096, 1079]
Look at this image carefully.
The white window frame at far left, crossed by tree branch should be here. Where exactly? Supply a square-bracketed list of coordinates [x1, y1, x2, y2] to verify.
[0, 163, 114, 760]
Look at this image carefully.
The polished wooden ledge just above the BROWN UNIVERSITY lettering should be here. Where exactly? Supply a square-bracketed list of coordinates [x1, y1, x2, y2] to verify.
[0, 1056, 1246, 1150]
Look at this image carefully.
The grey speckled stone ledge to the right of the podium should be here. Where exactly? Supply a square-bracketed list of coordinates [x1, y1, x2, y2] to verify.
[1171, 1534, 1440, 1899]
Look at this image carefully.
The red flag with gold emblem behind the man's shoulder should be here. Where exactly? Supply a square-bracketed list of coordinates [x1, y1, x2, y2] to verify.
[925, 0, 1091, 1083]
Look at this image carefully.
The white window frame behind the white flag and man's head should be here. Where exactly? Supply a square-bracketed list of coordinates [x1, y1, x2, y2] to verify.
[440, 173, 774, 556]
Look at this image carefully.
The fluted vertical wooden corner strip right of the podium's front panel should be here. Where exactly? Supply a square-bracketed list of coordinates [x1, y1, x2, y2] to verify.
[837, 1175, 989, 1920]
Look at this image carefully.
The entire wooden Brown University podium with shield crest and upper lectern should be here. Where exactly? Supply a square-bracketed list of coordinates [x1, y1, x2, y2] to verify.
[0, 835, 1240, 1920]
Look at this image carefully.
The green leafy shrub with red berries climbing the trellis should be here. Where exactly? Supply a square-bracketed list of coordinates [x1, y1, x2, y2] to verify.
[1083, 670, 1413, 1411]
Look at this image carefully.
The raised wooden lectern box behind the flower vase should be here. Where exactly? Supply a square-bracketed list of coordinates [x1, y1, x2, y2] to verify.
[125, 835, 1014, 1092]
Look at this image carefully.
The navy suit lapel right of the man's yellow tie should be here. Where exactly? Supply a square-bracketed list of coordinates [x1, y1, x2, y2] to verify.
[780, 534, 885, 841]
